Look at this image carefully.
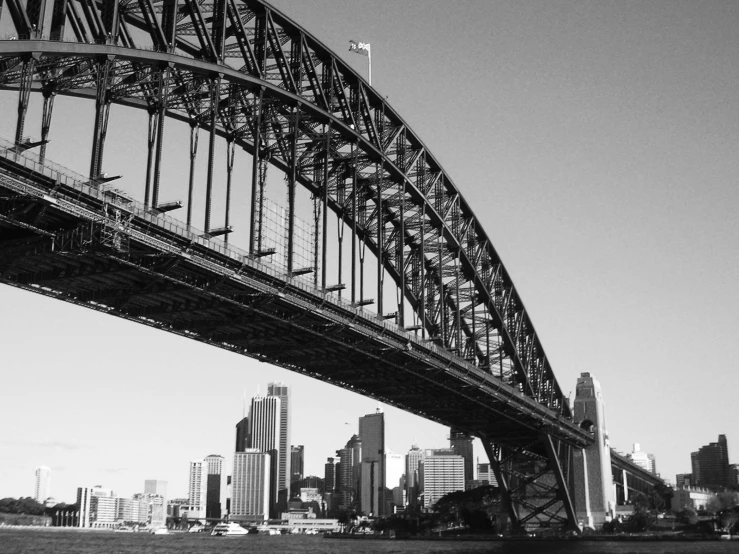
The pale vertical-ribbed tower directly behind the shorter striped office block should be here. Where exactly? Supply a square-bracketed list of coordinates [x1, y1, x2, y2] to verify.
[249, 396, 282, 517]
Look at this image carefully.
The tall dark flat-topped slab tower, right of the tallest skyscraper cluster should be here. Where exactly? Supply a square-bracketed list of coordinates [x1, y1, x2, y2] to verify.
[359, 409, 385, 516]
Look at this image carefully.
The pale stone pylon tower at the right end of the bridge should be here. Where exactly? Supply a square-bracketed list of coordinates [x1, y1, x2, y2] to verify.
[573, 373, 616, 529]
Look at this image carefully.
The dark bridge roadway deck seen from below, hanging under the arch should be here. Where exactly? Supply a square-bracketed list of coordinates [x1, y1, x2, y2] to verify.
[0, 148, 592, 449]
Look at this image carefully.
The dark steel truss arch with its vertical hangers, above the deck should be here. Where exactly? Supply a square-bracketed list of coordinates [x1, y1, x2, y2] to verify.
[0, 0, 583, 528]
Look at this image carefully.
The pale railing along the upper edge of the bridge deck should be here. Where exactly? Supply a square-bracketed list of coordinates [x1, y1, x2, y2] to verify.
[0, 137, 474, 374]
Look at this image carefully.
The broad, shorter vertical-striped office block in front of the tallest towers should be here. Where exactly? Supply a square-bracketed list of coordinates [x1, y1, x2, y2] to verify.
[229, 448, 275, 522]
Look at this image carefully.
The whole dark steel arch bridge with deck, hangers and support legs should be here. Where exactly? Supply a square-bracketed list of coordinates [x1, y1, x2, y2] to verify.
[0, 0, 592, 529]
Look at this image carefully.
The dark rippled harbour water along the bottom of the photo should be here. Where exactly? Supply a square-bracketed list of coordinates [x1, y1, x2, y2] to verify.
[0, 528, 739, 554]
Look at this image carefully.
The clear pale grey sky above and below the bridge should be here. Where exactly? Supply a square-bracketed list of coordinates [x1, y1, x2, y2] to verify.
[0, 0, 739, 502]
